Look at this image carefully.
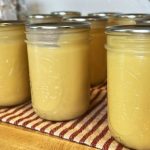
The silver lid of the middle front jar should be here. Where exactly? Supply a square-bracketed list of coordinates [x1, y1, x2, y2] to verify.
[27, 22, 90, 30]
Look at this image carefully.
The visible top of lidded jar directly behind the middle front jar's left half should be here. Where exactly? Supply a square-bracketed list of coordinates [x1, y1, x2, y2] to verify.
[27, 14, 62, 24]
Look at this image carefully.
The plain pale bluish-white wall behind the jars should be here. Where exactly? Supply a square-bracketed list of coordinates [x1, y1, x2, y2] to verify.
[26, 0, 150, 14]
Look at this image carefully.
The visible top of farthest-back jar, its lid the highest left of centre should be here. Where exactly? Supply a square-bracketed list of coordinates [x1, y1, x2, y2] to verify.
[51, 11, 81, 18]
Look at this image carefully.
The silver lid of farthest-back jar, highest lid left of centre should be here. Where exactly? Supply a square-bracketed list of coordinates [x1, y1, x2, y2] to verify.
[51, 11, 81, 16]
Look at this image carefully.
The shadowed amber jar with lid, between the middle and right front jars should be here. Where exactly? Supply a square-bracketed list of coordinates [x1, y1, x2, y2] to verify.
[65, 16, 107, 86]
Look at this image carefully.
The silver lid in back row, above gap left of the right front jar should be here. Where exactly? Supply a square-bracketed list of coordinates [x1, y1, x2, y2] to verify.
[88, 12, 121, 18]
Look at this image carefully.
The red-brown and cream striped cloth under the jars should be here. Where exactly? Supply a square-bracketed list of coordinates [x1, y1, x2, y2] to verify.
[0, 86, 127, 150]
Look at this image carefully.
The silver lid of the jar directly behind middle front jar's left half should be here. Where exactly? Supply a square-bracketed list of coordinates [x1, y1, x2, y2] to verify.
[28, 14, 60, 19]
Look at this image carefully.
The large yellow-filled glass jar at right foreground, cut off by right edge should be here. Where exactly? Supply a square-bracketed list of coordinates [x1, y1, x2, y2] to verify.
[106, 25, 150, 150]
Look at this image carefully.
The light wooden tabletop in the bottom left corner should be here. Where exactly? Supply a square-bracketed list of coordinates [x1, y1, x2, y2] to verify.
[0, 122, 96, 150]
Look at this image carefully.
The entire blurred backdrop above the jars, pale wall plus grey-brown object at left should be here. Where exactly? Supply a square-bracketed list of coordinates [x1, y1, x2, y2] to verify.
[0, 0, 150, 20]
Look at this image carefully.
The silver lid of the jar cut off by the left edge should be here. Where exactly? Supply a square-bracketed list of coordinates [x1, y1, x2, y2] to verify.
[0, 20, 24, 27]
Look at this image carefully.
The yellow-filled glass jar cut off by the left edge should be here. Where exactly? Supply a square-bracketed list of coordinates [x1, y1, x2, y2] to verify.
[0, 21, 30, 106]
